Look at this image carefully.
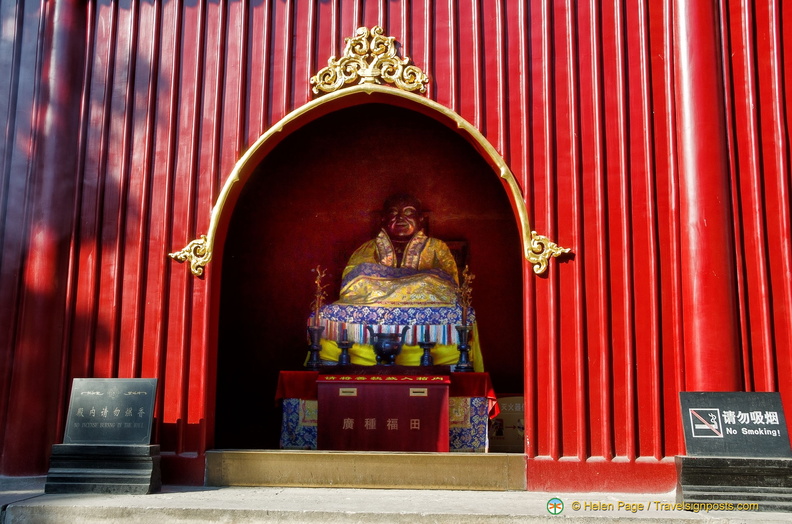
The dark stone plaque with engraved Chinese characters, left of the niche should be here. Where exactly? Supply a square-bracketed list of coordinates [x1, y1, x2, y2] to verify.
[63, 378, 157, 445]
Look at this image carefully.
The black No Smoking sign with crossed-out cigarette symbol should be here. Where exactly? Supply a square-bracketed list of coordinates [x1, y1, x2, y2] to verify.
[679, 391, 792, 458]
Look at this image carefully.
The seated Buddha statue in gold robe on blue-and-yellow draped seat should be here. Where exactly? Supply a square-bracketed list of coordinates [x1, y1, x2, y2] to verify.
[311, 195, 483, 371]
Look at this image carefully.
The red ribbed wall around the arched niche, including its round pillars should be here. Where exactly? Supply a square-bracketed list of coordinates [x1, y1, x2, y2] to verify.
[0, 0, 792, 491]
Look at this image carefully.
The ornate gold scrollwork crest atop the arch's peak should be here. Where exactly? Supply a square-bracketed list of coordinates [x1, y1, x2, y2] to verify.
[311, 26, 429, 95]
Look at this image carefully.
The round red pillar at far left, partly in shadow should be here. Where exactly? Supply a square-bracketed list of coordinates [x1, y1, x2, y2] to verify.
[0, 1, 85, 475]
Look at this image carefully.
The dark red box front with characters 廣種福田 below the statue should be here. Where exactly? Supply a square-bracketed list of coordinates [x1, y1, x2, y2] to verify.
[317, 374, 450, 451]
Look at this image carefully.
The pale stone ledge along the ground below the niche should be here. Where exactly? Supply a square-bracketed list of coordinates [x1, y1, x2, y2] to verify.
[0, 477, 789, 524]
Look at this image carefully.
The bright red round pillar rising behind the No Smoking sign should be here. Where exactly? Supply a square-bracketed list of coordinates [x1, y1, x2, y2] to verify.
[674, 0, 742, 391]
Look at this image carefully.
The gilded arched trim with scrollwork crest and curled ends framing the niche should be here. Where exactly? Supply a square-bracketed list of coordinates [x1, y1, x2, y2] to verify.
[168, 27, 570, 277]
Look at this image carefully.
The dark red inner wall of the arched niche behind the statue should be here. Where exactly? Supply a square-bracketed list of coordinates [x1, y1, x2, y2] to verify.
[215, 104, 523, 449]
